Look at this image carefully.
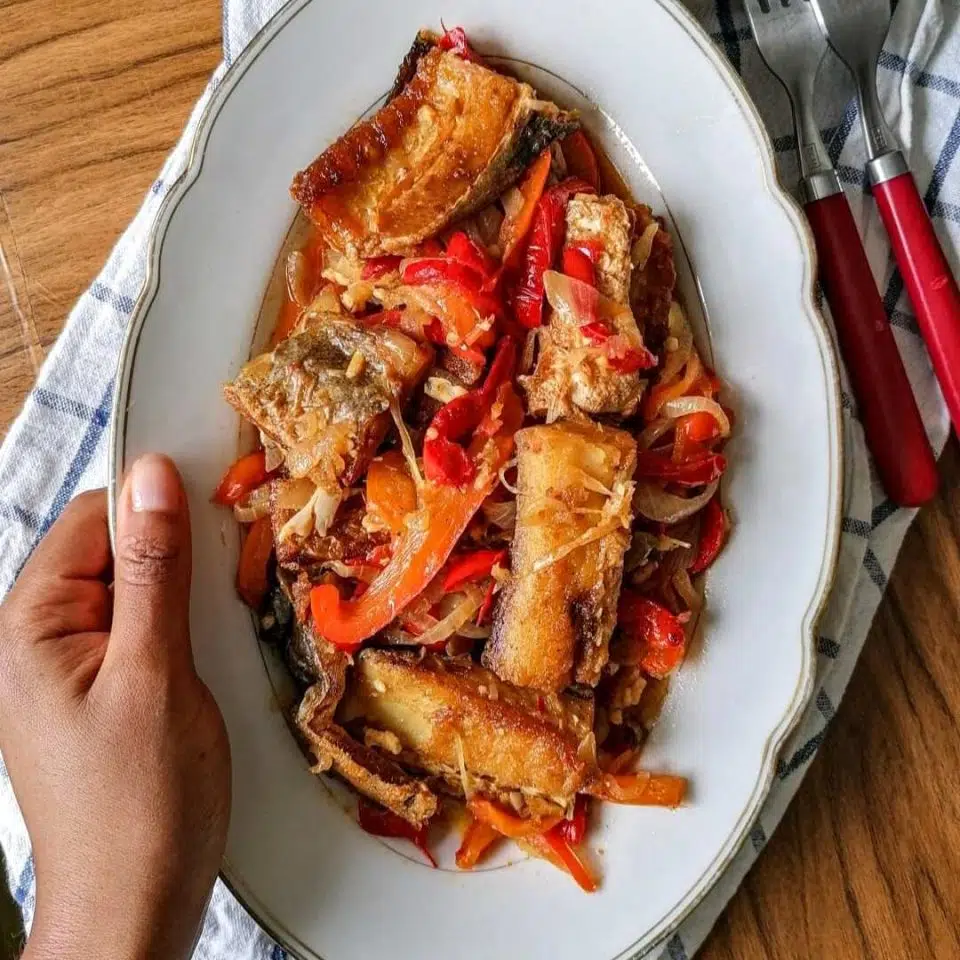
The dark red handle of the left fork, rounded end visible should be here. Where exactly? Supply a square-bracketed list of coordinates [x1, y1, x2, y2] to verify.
[806, 192, 937, 506]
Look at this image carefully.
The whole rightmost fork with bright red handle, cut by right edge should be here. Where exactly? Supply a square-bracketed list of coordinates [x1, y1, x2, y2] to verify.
[813, 0, 960, 433]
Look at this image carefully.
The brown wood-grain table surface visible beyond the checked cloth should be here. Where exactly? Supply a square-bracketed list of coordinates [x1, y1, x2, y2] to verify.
[0, 0, 960, 960]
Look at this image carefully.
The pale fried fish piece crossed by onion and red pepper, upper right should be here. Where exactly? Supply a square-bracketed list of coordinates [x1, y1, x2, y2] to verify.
[520, 194, 644, 423]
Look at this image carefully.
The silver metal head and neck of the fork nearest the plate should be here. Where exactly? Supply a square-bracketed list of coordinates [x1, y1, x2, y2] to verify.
[744, 0, 840, 200]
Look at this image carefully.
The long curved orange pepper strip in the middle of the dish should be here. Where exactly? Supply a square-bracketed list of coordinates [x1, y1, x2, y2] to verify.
[310, 382, 523, 652]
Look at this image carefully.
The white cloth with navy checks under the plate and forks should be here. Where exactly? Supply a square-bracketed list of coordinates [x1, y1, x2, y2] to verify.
[0, 0, 960, 960]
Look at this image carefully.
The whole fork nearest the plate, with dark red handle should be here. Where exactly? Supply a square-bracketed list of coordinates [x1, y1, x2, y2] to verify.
[744, 0, 937, 506]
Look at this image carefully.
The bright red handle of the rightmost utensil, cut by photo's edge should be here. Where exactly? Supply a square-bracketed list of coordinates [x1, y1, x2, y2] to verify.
[873, 172, 960, 433]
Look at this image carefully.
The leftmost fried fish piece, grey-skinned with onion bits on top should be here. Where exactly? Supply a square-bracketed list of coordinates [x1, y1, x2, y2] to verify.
[223, 313, 433, 492]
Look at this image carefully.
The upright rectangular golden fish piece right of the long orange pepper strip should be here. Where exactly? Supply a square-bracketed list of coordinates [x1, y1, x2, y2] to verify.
[483, 421, 637, 690]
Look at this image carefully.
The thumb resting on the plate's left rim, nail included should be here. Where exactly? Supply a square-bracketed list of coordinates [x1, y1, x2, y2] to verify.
[107, 454, 192, 665]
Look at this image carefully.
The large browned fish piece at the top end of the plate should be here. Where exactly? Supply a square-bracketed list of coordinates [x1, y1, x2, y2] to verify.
[290, 45, 577, 257]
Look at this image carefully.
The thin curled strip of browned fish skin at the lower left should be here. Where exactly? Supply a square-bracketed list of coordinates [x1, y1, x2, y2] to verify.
[297, 687, 438, 828]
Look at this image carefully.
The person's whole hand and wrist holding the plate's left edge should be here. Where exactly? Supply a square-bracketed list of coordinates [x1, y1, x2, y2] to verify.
[0, 455, 230, 960]
